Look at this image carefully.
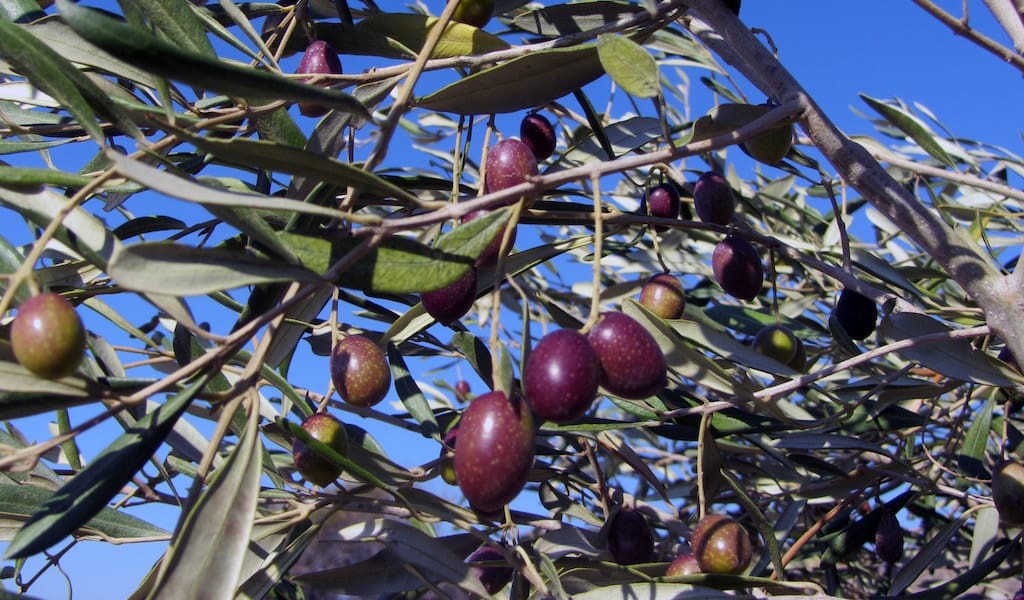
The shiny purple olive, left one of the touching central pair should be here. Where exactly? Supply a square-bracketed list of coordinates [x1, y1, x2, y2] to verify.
[522, 329, 601, 423]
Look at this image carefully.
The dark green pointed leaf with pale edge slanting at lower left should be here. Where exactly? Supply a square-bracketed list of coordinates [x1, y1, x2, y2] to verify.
[4, 370, 208, 559]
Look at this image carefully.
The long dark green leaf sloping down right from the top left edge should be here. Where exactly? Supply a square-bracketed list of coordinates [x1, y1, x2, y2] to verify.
[57, 0, 373, 121]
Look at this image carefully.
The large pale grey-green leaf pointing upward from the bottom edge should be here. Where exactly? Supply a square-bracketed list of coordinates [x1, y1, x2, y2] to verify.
[153, 406, 263, 600]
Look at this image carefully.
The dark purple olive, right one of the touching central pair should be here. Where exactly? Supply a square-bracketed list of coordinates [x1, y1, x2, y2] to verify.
[587, 311, 668, 400]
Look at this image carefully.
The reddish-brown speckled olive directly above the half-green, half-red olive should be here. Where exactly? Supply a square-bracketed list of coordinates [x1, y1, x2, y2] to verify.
[331, 336, 391, 406]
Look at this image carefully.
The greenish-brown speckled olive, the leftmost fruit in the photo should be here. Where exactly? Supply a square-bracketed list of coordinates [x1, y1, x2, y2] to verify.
[10, 292, 85, 379]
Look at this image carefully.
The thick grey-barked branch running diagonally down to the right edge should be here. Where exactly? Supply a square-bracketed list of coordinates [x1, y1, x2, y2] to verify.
[690, 0, 1024, 356]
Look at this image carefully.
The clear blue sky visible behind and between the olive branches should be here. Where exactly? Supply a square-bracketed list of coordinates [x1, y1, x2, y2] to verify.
[5, 0, 1024, 599]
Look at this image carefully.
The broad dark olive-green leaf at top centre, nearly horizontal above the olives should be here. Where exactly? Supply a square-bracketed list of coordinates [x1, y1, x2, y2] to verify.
[417, 45, 604, 115]
